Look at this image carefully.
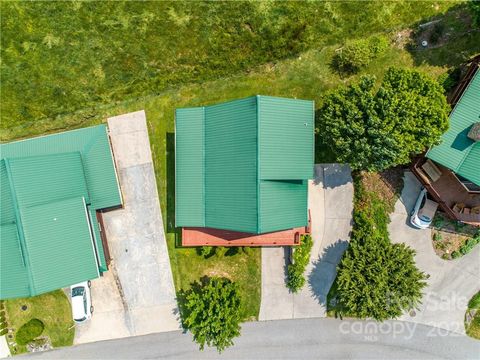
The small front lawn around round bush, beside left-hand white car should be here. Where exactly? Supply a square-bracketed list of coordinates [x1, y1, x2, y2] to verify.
[5, 290, 75, 354]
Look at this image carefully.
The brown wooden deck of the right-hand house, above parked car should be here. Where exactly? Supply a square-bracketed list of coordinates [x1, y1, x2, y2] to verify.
[411, 156, 480, 226]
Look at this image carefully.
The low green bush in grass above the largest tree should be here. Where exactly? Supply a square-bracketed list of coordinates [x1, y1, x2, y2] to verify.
[332, 36, 388, 73]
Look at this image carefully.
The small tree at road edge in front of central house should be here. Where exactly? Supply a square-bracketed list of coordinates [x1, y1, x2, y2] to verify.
[182, 278, 241, 352]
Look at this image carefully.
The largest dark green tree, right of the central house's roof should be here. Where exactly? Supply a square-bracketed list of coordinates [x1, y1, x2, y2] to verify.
[317, 68, 449, 171]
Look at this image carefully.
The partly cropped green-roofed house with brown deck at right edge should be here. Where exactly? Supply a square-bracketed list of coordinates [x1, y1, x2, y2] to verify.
[412, 57, 480, 226]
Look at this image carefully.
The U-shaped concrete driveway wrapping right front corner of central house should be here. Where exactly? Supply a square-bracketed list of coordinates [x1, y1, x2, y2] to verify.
[259, 164, 353, 320]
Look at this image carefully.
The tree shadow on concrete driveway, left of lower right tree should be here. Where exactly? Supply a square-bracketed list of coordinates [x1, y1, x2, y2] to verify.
[308, 240, 348, 308]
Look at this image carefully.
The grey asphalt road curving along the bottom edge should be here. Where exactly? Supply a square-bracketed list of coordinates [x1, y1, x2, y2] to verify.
[22, 319, 480, 359]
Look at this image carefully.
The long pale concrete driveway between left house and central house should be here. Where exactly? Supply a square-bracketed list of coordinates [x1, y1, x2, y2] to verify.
[75, 111, 180, 344]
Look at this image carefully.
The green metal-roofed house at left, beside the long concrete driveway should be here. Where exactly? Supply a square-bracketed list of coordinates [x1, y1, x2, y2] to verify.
[0, 125, 122, 299]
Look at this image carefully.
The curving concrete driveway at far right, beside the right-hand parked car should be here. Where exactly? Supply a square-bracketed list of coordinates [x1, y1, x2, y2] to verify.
[389, 171, 480, 334]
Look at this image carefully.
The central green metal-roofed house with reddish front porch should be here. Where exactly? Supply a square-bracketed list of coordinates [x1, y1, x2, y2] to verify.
[175, 96, 314, 246]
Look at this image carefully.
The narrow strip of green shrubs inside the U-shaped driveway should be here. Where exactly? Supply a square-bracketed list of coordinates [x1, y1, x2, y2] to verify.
[287, 235, 313, 293]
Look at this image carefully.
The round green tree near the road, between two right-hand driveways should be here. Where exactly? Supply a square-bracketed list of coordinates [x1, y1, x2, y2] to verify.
[336, 234, 426, 321]
